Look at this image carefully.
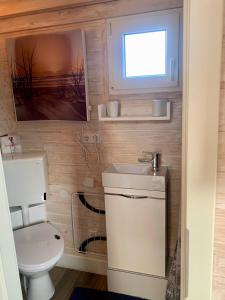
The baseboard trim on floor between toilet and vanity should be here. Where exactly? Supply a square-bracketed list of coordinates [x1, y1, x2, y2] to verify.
[57, 254, 107, 275]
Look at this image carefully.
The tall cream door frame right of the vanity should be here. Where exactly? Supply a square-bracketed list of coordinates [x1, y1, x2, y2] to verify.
[181, 0, 224, 300]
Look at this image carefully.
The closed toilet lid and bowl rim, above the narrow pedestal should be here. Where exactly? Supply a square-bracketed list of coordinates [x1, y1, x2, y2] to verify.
[14, 223, 64, 272]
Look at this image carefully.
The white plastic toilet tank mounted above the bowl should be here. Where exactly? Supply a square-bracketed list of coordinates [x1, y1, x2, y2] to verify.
[3, 152, 48, 207]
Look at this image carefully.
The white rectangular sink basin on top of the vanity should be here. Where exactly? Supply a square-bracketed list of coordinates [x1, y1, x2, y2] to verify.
[102, 164, 167, 191]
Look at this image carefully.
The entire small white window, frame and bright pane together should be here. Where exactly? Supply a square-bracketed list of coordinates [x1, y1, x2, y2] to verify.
[108, 9, 180, 94]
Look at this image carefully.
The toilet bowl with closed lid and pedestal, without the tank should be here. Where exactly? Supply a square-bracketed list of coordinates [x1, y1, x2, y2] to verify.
[14, 222, 64, 300]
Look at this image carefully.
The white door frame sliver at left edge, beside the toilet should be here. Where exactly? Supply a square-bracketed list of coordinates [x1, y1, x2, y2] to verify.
[0, 153, 23, 300]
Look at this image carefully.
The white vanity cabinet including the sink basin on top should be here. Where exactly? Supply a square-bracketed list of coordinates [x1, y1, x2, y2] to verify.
[102, 164, 167, 300]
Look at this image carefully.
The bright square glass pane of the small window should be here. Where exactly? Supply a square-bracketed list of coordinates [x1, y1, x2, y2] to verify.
[124, 30, 166, 77]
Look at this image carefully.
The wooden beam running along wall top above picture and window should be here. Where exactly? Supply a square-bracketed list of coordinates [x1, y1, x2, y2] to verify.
[0, 0, 183, 33]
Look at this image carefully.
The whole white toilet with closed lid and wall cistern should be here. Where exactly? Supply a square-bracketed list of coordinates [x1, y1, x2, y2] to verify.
[3, 152, 64, 300]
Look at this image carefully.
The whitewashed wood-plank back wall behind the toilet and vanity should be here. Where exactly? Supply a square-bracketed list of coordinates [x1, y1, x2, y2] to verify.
[0, 0, 182, 262]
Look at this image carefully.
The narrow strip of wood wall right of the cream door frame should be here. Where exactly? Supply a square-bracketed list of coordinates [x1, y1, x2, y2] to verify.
[213, 15, 225, 300]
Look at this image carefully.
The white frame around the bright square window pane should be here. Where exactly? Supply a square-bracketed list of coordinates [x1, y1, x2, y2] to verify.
[107, 9, 182, 94]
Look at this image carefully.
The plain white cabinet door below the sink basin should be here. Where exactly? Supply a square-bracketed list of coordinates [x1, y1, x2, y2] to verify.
[105, 195, 166, 276]
